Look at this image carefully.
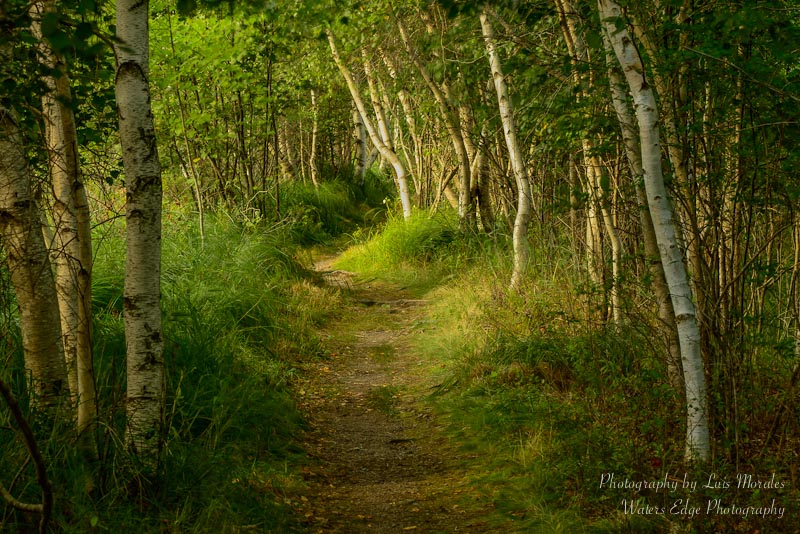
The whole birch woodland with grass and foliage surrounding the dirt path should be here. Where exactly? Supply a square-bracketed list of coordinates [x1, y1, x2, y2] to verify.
[0, 0, 800, 532]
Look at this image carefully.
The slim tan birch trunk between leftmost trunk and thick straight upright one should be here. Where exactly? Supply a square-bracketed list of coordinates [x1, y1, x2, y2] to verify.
[31, 0, 97, 456]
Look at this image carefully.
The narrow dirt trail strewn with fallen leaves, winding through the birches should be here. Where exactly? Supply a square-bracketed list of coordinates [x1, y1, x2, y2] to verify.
[290, 260, 499, 534]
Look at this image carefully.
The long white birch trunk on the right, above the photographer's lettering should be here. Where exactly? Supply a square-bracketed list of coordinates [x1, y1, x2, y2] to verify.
[598, 0, 711, 462]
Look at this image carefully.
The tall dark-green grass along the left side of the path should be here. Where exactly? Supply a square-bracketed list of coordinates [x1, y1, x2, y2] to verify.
[0, 203, 339, 532]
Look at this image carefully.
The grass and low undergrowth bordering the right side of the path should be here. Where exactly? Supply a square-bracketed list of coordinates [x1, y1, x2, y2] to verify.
[338, 209, 798, 533]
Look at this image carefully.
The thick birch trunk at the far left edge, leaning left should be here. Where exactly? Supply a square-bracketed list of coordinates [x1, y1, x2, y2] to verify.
[0, 105, 69, 412]
